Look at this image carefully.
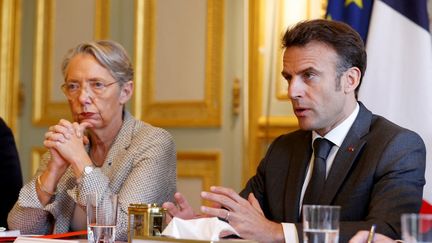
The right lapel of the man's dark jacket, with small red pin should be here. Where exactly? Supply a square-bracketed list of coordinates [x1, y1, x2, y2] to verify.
[320, 102, 372, 205]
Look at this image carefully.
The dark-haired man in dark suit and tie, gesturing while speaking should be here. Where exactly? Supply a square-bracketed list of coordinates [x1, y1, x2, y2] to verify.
[164, 20, 426, 242]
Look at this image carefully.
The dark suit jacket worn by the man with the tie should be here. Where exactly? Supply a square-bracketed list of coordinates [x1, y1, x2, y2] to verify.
[240, 103, 426, 242]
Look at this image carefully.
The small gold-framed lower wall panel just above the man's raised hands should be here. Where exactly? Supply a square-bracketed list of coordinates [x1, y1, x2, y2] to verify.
[177, 151, 220, 205]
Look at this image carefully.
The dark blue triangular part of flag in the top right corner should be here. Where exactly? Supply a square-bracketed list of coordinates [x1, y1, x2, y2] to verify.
[381, 0, 429, 31]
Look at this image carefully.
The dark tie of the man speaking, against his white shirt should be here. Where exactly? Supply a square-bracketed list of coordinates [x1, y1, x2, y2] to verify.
[303, 138, 333, 204]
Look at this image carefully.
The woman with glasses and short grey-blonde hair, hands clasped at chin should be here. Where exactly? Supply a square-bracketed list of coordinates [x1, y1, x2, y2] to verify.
[8, 40, 176, 241]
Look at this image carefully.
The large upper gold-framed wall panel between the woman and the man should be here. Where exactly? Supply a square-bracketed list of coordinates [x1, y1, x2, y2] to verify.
[133, 0, 224, 127]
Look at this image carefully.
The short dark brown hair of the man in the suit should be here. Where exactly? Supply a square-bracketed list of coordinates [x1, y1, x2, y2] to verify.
[282, 19, 366, 97]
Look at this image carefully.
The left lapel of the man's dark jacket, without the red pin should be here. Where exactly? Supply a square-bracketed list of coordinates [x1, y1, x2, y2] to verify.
[284, 132, 312, 222]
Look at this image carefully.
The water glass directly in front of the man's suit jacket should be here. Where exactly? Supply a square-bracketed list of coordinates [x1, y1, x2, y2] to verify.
[303, 205, 340, 243]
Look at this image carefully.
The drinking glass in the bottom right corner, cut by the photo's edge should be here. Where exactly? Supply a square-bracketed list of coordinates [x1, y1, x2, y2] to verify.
[401, 214, 432, 243]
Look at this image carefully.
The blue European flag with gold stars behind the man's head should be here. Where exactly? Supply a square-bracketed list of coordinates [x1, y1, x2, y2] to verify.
[326, 0, 373, 43]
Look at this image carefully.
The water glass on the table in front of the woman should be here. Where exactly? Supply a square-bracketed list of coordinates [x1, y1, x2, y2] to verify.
[87, 194, 117, 243]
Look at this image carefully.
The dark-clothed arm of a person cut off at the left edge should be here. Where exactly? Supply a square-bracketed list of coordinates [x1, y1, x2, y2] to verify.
[0, 118, 22, 227]
